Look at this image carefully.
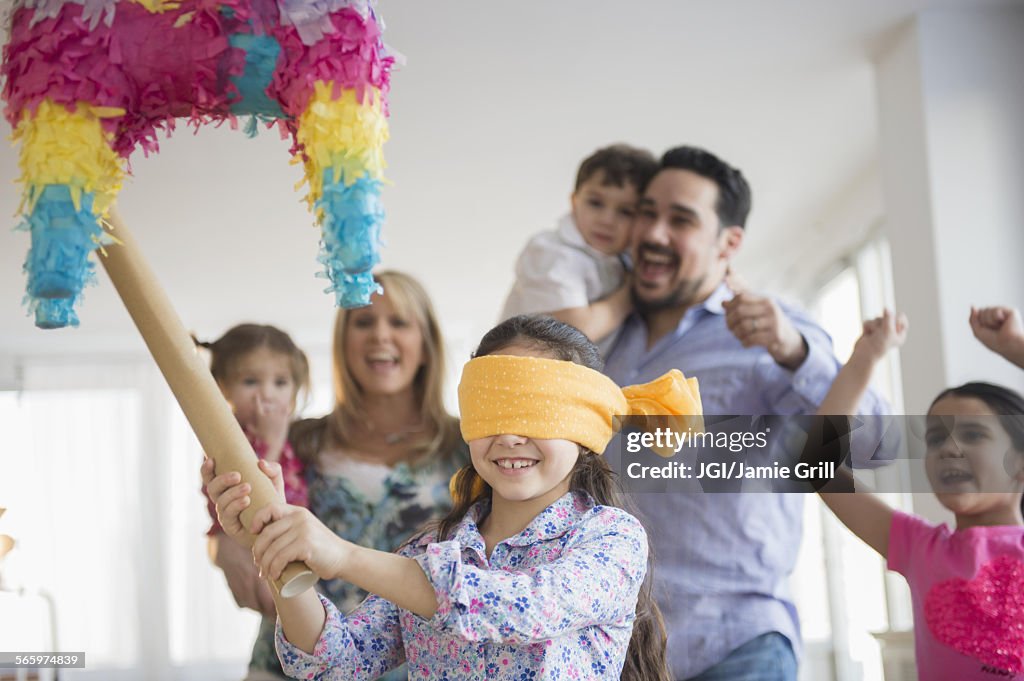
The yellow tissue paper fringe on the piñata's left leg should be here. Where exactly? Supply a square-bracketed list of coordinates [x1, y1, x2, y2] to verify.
[11, 99, 125, 217]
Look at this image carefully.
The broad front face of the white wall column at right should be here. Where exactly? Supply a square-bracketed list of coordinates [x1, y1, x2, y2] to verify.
[919, 5, 1024, 389]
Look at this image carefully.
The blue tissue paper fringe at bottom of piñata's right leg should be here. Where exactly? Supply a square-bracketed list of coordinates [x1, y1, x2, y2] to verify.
[316, 168, 384, 308]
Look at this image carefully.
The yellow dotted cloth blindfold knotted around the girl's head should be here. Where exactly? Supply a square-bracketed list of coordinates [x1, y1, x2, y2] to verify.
[459, 354, 703, 456]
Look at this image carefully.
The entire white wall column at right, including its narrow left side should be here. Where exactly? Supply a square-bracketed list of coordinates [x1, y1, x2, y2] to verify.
[878, 6, 1024, 413]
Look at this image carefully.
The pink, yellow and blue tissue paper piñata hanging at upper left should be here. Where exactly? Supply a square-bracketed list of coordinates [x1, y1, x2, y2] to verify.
[3, 0, 394, 328]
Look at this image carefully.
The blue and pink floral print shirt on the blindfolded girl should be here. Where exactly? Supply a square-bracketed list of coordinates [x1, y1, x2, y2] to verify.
[278, 492, 647, 681]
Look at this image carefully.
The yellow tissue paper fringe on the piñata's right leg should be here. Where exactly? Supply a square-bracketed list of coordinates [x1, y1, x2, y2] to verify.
[295, 82, 388, 217]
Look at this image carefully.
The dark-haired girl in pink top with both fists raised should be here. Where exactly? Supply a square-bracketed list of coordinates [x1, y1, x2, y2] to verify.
[818, 308, 1024, 681]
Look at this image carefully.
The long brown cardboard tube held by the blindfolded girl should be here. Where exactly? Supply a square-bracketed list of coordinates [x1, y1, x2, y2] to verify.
[100, 209, 316, 597]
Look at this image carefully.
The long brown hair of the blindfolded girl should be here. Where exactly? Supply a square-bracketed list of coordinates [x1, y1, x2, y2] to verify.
[437, 314, 672, 681]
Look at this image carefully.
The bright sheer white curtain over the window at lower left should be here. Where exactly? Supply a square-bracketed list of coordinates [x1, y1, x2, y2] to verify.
[0, 357, 258, 680]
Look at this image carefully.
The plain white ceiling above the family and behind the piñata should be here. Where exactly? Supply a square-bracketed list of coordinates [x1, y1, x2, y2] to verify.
[0, 0, 991, 364]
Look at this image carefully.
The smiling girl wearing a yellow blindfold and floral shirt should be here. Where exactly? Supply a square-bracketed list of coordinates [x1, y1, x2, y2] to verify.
[206, 315, 700, 681]
